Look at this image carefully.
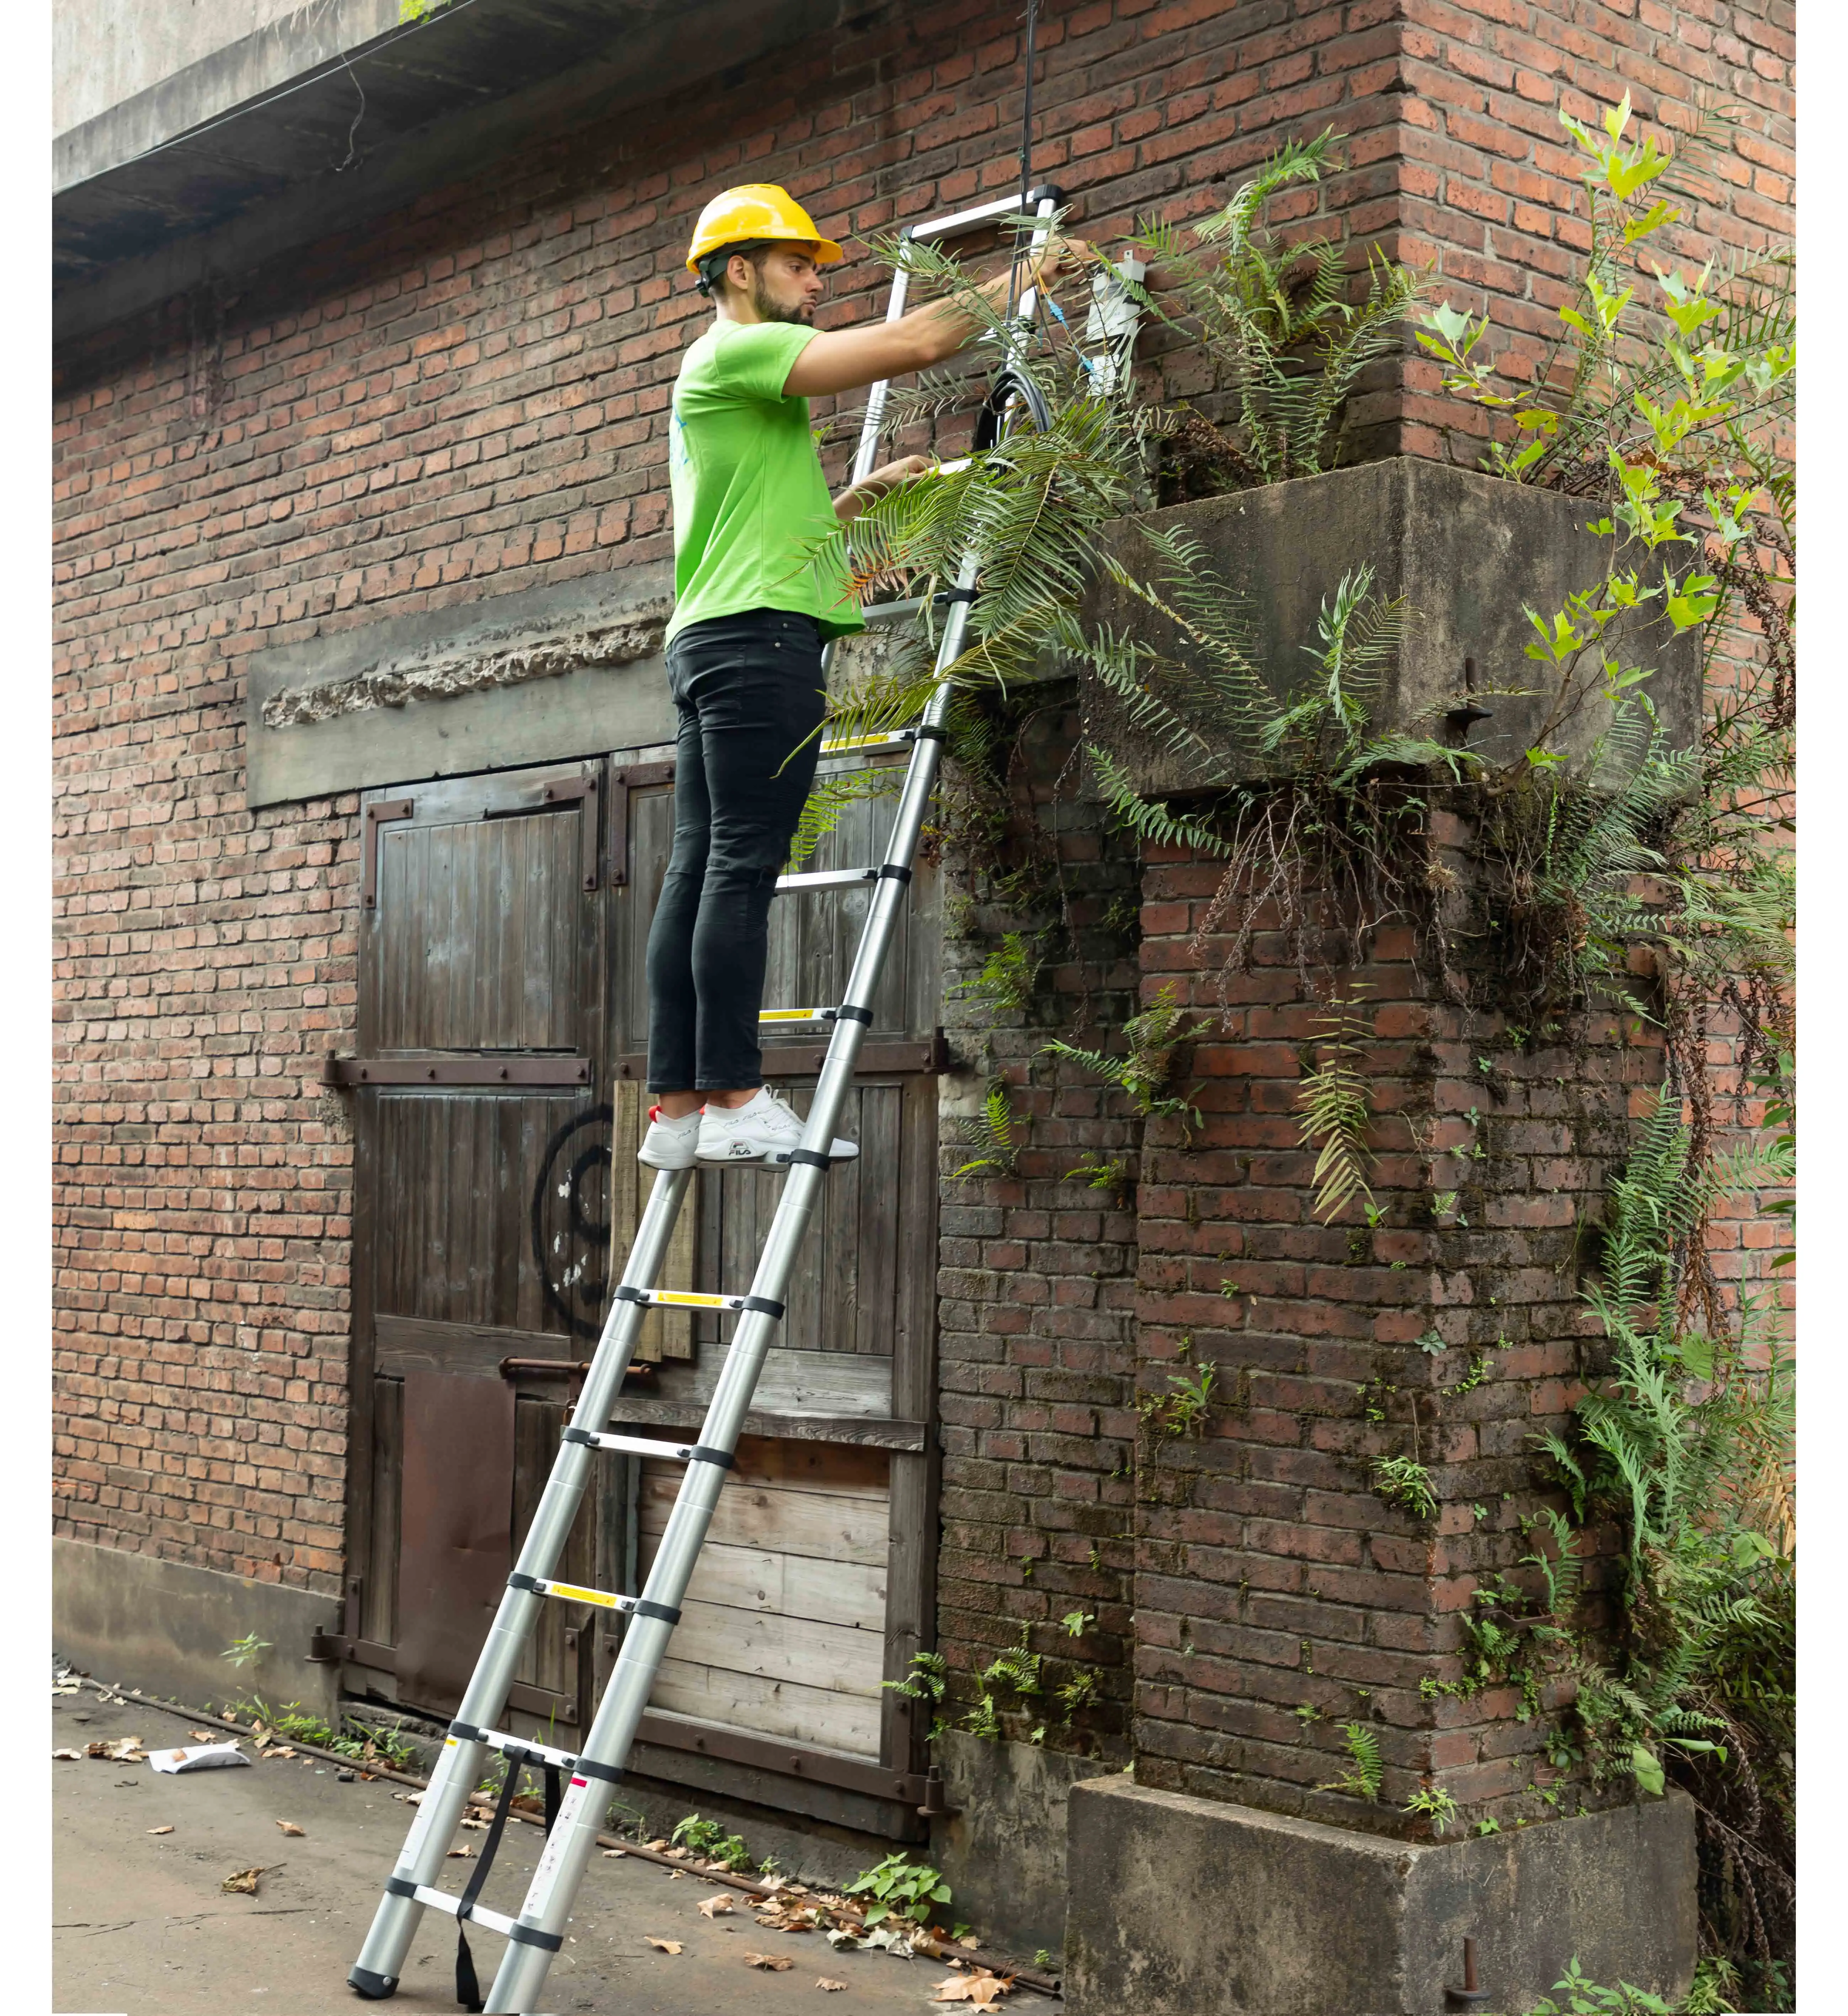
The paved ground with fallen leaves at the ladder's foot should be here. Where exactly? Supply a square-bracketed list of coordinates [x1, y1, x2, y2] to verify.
[50, 1690, 1007, 2016]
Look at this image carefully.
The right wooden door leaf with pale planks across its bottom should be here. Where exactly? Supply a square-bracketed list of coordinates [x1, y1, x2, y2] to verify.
[611, 758, 941, 1835]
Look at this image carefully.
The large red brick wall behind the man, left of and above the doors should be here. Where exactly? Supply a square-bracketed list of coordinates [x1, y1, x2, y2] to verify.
[54, 0, 1788, 1615]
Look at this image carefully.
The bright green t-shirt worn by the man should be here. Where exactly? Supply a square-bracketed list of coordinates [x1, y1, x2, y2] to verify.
[667, 323, 864, 637]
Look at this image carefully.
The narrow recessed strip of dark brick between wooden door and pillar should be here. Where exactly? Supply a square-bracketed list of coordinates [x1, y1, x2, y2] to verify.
[937, 687, 1141, 1758]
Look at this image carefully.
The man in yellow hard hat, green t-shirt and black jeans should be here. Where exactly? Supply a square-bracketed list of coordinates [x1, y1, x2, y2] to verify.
[641, 181, 1086, 1169]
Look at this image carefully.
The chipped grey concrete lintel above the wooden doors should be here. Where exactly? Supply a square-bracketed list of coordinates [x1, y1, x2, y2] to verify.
[246, 563, 675, 807]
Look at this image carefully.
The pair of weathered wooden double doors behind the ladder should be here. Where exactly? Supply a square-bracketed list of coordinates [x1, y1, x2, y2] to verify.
[339, 752, 941, 1836]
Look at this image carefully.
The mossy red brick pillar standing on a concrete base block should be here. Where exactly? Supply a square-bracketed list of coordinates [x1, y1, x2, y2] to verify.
[1135, 814, 1663, 1826]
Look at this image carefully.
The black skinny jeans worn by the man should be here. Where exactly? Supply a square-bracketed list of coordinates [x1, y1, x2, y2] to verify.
[649, 609, 824, 1093]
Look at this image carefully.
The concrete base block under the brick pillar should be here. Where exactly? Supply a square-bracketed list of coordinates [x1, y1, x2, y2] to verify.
[1066, 1776, 1699, 2016]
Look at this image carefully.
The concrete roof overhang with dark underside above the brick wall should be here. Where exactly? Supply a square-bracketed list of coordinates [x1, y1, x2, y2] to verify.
[52, 0, 834, 347]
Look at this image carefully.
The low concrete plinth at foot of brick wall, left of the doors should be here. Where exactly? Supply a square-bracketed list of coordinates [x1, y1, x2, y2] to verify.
[50, 1536, 341, 1734]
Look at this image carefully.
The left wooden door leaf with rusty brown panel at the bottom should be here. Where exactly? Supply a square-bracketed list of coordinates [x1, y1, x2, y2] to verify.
[335, 762, 611, 1724]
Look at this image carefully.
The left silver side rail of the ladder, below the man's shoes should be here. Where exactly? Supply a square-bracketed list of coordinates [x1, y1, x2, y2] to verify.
[348, 1169, 705, 1994]
